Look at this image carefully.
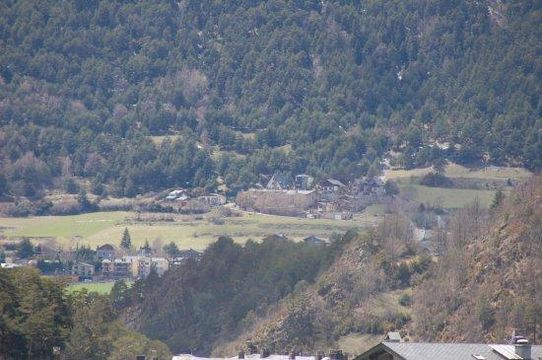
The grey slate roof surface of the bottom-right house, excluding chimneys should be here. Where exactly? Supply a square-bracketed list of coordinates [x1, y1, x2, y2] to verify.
[356, 342, 542, 360]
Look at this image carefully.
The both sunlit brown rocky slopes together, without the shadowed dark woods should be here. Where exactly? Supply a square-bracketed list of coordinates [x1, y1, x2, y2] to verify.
[209, 178, 542, 355]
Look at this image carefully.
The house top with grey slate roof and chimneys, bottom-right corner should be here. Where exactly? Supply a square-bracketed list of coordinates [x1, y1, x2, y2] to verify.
[354, 334, 542, 360]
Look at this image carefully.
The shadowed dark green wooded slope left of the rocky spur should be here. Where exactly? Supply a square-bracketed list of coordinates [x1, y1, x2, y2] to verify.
[121, 236, 345, 354]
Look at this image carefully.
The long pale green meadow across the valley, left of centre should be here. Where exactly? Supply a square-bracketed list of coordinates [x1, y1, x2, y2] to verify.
[0, 212, 368, 250]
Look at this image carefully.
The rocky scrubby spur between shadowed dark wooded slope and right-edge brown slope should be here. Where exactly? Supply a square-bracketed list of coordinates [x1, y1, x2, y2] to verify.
[214, 215, 431, 356]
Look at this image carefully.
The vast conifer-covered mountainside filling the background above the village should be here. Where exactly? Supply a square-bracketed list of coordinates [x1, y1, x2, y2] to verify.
[0, 0, 542, 197]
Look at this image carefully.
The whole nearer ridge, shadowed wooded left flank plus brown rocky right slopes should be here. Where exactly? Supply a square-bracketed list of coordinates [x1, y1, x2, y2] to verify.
[120, 178, 542, 356]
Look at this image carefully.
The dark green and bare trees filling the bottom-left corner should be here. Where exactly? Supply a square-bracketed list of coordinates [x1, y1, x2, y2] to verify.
[0, 268, 171, 360]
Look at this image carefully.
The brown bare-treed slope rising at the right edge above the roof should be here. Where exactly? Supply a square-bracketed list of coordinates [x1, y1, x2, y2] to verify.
[412, 178, 542, 343]
